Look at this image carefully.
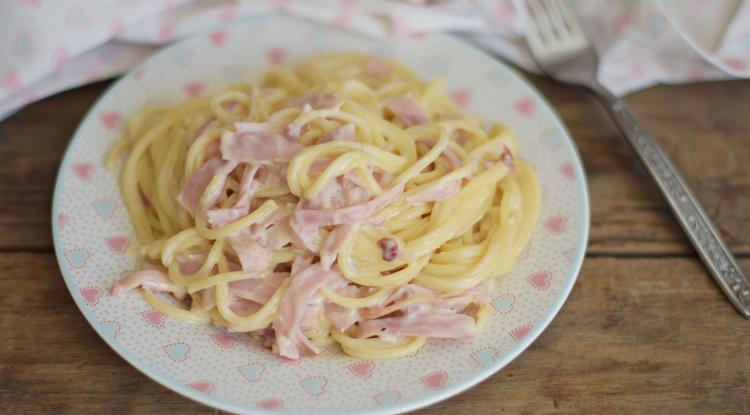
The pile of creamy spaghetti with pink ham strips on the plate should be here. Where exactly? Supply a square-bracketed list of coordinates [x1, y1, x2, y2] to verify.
[107, 54, 540, 359]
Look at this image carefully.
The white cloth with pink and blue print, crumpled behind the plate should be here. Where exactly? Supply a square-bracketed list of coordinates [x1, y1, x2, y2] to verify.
[0, 0, 750, 120]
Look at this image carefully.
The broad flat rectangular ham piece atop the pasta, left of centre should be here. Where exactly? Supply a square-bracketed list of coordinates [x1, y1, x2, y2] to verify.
[221, 131, 302, 164]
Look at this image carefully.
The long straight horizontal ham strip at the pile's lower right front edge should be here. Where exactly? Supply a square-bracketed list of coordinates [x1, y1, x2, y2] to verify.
[356, 313, 476, 339]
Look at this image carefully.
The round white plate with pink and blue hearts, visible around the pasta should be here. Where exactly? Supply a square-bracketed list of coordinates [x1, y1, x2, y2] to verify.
[52, 16, 589, 414]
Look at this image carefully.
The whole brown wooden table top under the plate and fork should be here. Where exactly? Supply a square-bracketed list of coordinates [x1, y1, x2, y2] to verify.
[0, 77, 750, 414]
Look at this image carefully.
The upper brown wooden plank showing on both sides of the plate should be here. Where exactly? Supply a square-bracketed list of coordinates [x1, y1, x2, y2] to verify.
[0, 76, 750, 255]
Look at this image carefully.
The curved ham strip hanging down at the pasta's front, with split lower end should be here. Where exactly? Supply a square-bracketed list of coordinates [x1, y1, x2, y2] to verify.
[273, 264, 347, 360]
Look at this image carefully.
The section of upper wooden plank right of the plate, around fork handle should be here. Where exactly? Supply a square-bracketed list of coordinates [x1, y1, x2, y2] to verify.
[529, 76, 750, 254]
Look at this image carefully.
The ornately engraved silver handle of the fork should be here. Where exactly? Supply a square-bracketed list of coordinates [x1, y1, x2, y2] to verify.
[596, 90, 750, 319]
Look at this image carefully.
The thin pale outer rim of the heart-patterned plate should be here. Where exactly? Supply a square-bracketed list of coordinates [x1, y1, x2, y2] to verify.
[51, 13, 591, 415]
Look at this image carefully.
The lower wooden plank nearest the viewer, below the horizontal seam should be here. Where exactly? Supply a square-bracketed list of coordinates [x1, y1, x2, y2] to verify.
[0, 253, 750, 415]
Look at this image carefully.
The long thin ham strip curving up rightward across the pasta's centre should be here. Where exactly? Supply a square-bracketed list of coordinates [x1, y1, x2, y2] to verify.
[294, 184, 404, 226]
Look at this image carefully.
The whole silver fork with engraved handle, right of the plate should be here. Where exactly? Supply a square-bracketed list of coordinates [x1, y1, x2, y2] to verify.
[526, 0, 750, 319]
